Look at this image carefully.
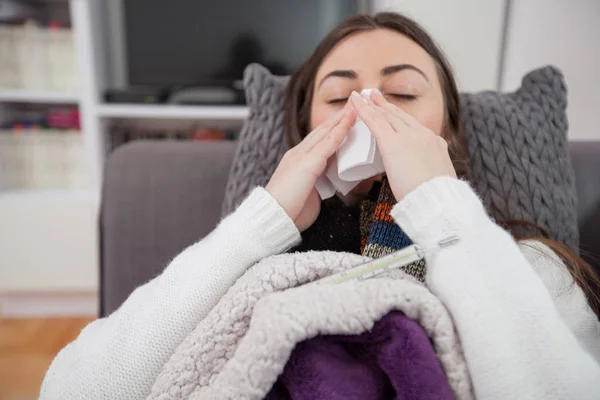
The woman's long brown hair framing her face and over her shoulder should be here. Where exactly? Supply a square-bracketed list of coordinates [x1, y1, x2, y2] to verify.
[284, 12, 600, 316]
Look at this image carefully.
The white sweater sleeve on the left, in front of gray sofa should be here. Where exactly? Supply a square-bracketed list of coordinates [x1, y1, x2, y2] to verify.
[40, 188, 300, 400]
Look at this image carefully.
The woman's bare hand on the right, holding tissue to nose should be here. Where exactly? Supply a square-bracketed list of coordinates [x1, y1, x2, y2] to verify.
[350, 90, 456, 201]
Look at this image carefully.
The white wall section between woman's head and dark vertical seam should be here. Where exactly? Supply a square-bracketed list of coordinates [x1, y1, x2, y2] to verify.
[373, 0, 506, 91]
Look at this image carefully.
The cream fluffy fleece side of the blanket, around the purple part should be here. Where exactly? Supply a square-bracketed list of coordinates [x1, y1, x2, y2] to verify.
[148, 252, 474, 400]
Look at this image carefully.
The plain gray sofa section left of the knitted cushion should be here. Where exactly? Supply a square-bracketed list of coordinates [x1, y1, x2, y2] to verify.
[100, 141, 237, 315]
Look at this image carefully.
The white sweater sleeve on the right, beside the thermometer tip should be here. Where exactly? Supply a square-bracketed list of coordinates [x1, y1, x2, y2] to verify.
[392, 177, 600, 400]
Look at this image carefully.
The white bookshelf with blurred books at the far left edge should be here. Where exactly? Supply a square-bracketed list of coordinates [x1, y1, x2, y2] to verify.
[0, 0, 89, 318]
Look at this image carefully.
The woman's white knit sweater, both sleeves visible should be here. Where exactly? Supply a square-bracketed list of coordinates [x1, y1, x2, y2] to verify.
[40, 177, 600, 400]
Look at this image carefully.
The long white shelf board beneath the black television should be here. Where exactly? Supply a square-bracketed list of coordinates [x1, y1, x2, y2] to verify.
[98, 104, 248, 121]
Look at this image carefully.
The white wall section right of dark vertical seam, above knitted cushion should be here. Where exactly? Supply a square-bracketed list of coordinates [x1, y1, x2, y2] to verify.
[502, 0, 600, 140]
